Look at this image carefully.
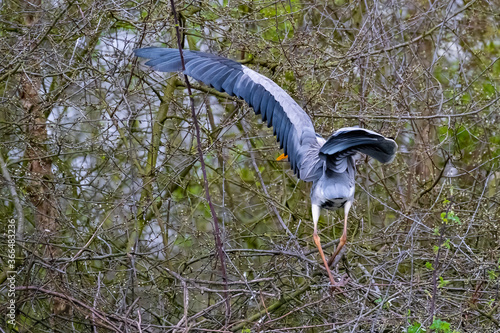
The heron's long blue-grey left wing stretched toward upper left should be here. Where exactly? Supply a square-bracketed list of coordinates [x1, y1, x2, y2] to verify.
[134, 47, 322, 181]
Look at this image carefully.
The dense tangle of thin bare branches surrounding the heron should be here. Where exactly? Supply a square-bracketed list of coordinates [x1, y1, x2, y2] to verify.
[0, 0, 500, 332]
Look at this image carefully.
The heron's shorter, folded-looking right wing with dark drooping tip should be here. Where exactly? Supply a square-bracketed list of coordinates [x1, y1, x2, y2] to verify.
[319, 127, 398, 172]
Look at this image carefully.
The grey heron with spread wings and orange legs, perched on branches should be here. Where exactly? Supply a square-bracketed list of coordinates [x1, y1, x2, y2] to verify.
[134, 47, 397, 287]
